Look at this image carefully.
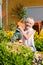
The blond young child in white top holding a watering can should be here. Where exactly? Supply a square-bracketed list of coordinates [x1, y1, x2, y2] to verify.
[18, 18, 36, 52]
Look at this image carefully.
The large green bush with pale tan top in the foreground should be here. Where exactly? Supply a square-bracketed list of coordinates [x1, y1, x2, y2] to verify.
[0, 42, 34, 65]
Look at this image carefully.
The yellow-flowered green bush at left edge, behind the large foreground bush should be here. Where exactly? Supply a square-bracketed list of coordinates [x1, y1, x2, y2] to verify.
[0, 30, 14, 43]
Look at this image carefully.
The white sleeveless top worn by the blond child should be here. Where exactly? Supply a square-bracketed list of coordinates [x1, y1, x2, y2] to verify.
[22, 28, 34, 47]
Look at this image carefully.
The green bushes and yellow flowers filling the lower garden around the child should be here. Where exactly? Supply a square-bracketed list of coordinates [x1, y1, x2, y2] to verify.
[0, 25, 43, 65]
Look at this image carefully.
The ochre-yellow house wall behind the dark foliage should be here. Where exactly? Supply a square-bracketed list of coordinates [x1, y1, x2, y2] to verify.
[3, 0, 43, 28]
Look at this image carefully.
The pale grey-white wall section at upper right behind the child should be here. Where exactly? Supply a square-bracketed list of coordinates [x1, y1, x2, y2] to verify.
[26, 6, 43, 21]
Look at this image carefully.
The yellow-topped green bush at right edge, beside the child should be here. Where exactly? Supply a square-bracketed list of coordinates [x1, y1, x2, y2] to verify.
[34, 30, 43, 51]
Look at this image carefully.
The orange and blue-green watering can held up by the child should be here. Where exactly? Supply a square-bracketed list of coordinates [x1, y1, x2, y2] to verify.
[11, 20, 24, 42]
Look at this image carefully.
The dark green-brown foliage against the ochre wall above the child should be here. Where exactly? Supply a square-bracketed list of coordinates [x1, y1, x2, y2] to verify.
[12, 4, 26, 19]
